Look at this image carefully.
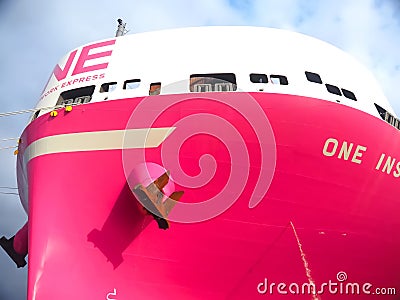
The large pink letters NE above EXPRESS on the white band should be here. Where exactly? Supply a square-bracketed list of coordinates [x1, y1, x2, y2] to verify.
[53, 39, 115, 81]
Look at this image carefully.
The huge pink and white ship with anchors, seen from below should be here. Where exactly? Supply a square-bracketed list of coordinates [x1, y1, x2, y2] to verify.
[0, 24, 400, 300]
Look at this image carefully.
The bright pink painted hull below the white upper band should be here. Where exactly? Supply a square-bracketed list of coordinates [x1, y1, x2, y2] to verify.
[20, 93, 400, 300]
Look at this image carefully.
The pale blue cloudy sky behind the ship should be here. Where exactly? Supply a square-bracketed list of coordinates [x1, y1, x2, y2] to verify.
[0, 0, 400, 300]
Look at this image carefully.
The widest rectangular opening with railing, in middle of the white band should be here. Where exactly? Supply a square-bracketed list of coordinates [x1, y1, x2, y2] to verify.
[190, 73, 237, 93]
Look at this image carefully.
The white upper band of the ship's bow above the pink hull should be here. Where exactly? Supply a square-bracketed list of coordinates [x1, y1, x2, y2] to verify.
[36, 27, 394, 118]
